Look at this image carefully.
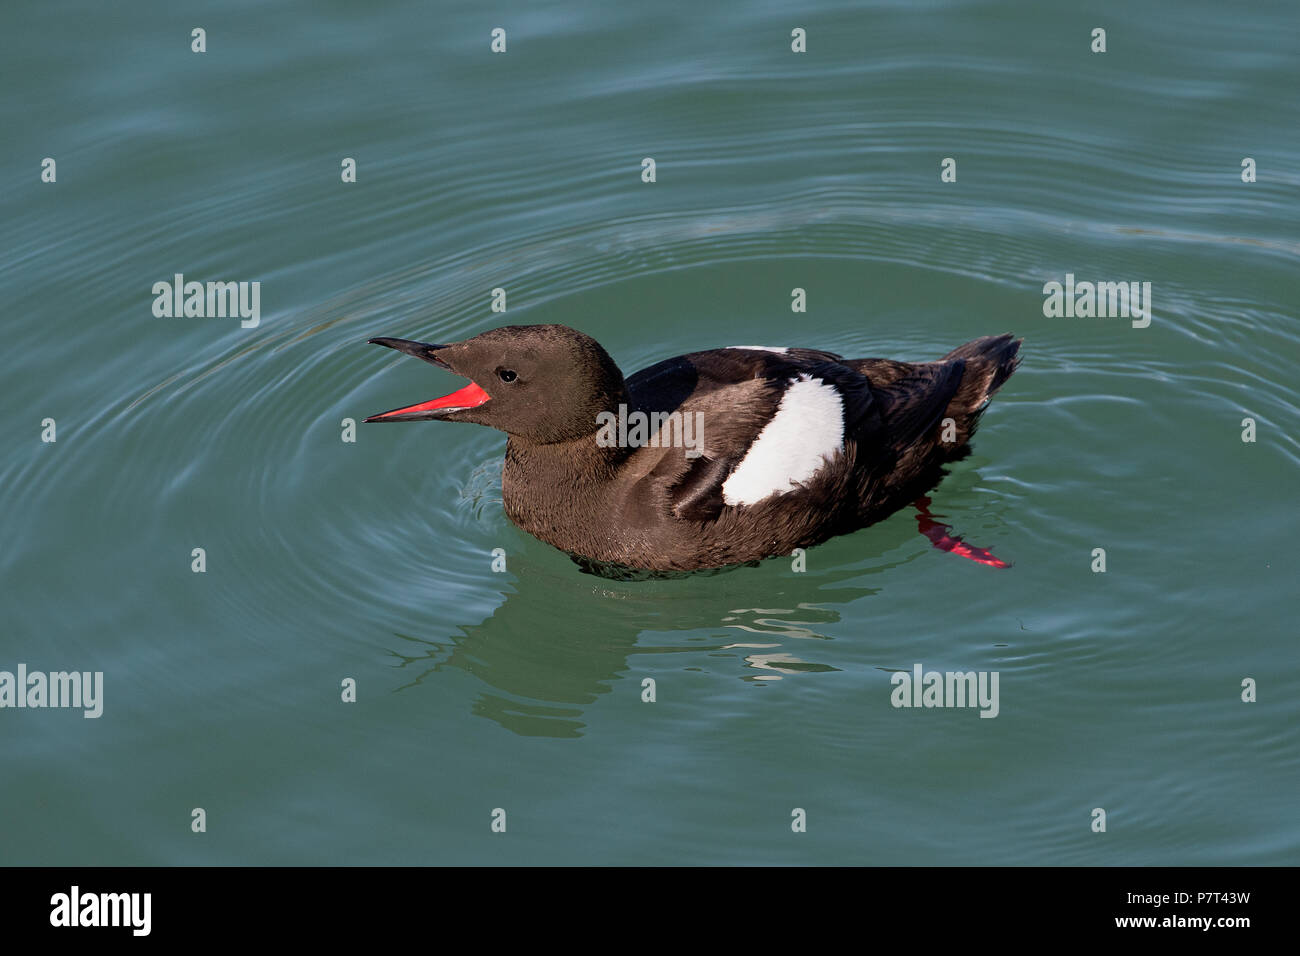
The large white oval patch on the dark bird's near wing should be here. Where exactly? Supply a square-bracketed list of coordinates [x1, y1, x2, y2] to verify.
[723, 373, 844, 505]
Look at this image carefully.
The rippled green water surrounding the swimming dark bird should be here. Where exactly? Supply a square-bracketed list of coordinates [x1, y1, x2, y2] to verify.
[0, 0, 1300, 865]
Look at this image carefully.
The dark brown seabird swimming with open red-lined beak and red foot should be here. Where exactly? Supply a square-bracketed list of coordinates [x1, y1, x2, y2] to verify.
[365, 325, 1023, 576]
